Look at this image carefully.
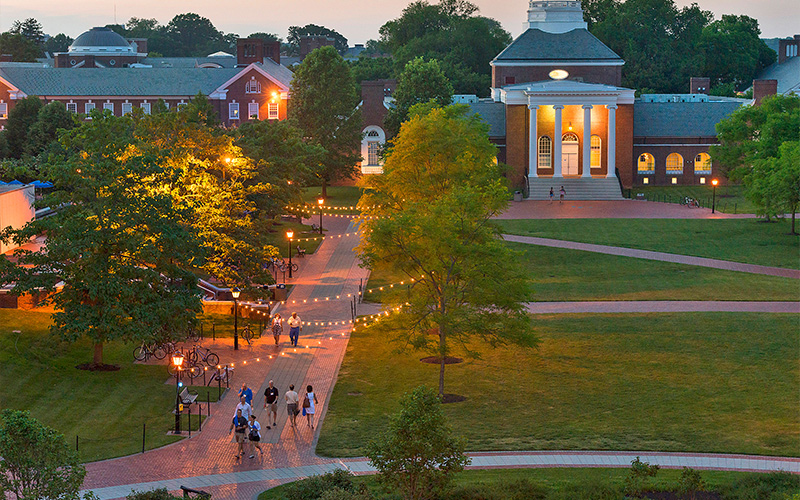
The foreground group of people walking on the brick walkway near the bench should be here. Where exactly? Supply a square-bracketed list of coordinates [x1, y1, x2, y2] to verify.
[228, 380, 318, 459]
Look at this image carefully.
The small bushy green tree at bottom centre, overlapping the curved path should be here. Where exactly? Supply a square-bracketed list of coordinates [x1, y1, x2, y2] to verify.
[366, 386, 470, 500]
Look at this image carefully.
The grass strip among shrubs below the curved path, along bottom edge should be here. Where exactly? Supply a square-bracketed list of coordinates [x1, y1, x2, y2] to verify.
[258, 468, 800, 500]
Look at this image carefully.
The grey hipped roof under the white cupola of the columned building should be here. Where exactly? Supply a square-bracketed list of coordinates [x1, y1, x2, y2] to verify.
[494, 28, 622, 62]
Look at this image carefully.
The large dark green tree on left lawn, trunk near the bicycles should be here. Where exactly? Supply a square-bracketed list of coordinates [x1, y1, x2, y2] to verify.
[0, 110, 201, 369]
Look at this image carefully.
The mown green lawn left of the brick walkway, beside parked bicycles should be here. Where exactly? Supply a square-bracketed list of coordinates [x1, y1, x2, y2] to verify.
[0, 309, 213, 461]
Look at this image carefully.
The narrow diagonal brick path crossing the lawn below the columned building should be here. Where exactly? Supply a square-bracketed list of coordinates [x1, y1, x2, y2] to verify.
[503, 234, 800, 279]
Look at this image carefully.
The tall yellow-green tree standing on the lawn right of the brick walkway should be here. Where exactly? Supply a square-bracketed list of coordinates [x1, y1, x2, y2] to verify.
[358, 105, 536, 396]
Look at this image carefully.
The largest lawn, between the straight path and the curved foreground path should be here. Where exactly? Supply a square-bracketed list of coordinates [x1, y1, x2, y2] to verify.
[317, 313, 800, 456]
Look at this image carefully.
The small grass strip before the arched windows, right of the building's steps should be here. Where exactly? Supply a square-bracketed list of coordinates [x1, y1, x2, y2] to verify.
[623, 183, 756, 214]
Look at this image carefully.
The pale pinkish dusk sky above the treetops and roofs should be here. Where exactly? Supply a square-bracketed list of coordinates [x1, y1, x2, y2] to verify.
[0, 0, 800, 45]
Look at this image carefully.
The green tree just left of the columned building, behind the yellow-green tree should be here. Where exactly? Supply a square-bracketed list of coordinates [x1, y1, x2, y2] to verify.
[385, 57, 453, 136]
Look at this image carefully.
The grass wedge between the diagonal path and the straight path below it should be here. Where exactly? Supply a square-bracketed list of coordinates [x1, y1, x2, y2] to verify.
[364, 243, 800, 302]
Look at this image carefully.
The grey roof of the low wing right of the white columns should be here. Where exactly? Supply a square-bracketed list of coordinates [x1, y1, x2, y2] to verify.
[633, 99, 751, 137]
